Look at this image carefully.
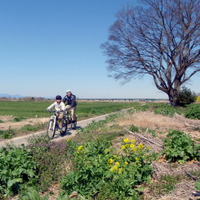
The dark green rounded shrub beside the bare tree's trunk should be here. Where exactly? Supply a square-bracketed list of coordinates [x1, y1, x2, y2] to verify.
[177, 87, 197, 106]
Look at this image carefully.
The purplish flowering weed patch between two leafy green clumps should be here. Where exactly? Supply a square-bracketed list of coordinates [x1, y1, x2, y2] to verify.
[28, 138, 68, 191]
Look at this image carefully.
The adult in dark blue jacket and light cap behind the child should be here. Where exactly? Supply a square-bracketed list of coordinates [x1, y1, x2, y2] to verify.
[63, 90, 77, 128]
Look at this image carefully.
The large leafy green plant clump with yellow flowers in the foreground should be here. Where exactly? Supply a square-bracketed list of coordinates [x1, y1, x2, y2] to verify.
[60, 138, 152, 199]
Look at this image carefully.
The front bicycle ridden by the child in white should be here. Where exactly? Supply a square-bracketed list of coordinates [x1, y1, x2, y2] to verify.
[47, 110, 67, 139]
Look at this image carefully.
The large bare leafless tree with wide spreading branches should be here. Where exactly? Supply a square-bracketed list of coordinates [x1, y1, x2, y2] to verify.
[102, 0, 200, 106]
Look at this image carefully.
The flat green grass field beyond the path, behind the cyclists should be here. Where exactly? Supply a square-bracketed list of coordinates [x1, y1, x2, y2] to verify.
[0, 101, 138, 119]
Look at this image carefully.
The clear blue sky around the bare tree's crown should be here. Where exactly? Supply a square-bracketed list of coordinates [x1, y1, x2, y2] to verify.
[0, 0, 200, 98]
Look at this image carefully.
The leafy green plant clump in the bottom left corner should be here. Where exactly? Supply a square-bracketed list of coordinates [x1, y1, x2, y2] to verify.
[0, 146, 38, 196]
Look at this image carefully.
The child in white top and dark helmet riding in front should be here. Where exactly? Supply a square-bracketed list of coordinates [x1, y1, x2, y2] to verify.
[47, 95, 65, 129]
